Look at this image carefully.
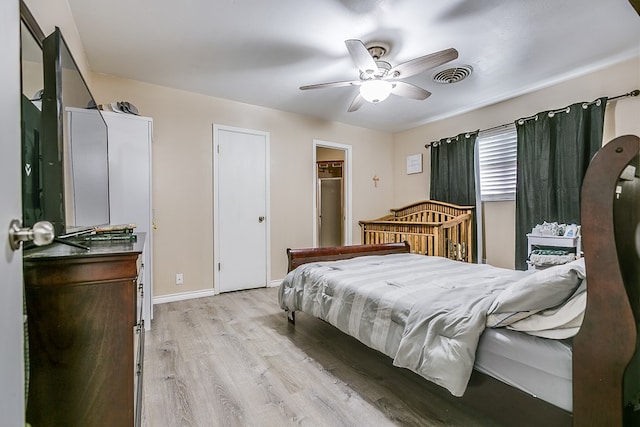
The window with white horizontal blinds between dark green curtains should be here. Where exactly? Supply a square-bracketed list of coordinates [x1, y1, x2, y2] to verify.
[476, 124, 518, 202]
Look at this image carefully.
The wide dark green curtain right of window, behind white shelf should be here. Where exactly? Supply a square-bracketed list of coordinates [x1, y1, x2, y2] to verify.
[515, 98, 607, 270]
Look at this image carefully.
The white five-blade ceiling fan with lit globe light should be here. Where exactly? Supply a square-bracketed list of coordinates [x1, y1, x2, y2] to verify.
[300, 39, 458, 112]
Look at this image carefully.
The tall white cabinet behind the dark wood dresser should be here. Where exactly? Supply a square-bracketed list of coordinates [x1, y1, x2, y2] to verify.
[103, 111, 153, 330]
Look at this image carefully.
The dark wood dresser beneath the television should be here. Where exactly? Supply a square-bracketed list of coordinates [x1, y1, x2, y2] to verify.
[24, 234, 144, 427]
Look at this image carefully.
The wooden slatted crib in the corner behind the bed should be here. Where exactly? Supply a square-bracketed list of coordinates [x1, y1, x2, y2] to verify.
[358, 200, 475, 262]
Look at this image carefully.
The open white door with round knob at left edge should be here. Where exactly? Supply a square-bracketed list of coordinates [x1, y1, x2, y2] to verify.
[0, 1, 24, 426]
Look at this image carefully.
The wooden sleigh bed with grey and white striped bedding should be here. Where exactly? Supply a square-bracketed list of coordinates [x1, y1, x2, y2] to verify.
[279, 136, 640, 426]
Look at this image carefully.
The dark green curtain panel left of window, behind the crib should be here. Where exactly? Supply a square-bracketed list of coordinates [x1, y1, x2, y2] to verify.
[429, 131, 478, 262]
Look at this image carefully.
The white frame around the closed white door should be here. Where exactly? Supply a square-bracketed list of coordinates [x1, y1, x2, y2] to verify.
[211, 123, 271, 295]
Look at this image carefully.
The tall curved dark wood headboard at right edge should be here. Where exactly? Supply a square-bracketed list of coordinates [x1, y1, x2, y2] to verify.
[573, 135, 640, 426]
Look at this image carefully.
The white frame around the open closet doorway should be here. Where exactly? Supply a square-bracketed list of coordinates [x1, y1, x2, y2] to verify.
[311, 139, 353, 248]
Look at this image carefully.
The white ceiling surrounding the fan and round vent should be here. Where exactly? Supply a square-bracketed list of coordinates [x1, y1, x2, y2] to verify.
[69, 0, 640, 132]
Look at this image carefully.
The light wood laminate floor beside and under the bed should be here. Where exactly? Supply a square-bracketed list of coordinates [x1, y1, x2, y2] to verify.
[143, 288, 496, 427]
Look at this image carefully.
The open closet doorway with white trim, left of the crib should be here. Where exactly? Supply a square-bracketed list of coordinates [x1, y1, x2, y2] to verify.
[313, 140, 352, 247]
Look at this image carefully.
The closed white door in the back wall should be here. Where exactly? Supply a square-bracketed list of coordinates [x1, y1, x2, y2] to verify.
[213, 125, 269, 292]
